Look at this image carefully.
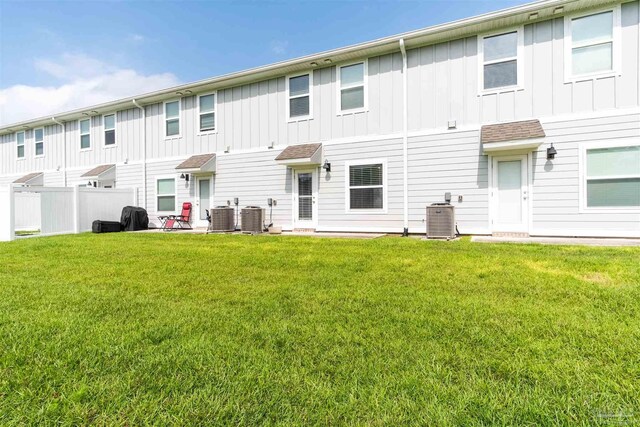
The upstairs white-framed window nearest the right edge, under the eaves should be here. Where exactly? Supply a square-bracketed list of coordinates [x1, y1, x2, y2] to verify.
[565, 9, 617, 77]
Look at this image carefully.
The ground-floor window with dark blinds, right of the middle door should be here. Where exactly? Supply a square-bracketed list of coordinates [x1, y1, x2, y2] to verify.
[348, 163, 384, 210]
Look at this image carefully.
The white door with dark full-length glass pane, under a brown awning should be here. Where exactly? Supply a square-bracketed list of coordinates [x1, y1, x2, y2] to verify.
[293, 169, 318, 229]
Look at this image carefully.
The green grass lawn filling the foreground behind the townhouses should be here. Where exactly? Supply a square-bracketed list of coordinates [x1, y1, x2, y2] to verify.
[0, 233, 640, 426]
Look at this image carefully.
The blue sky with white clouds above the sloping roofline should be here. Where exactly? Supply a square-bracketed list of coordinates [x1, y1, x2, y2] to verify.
[0, 0, 526, 124]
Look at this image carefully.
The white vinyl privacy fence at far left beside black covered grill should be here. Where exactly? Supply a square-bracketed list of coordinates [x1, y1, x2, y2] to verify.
[0, 186, 137, 241]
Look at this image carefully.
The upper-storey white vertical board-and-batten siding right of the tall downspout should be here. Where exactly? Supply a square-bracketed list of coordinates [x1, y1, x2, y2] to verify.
[407, 1, 640, 131]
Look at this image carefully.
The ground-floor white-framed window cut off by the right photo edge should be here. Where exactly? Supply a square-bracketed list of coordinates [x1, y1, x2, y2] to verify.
[585, 145, 640, 208]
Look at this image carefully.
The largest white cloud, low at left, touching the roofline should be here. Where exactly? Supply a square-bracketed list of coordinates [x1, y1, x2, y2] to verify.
[0, 55, 180, 125]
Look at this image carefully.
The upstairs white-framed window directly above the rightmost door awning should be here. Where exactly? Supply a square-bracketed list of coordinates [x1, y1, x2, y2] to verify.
[480, 30, 522, 90]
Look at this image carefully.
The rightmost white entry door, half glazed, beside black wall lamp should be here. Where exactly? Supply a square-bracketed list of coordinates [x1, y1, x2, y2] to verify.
[491, 155, 529, 233]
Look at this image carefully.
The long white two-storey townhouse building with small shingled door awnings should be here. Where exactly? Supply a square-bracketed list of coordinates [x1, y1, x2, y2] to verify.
[0, 0, 640, 237]
